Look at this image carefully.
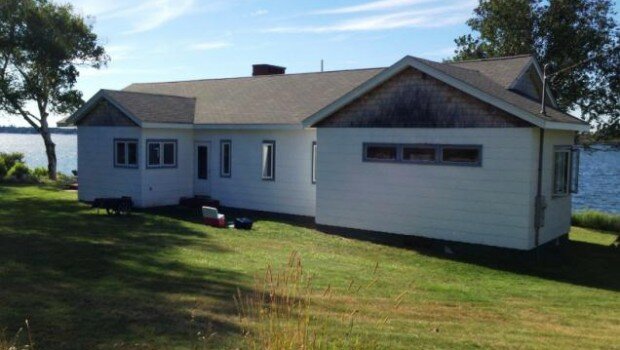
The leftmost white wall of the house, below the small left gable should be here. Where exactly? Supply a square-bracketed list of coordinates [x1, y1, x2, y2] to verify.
[78, 126, 144, 206]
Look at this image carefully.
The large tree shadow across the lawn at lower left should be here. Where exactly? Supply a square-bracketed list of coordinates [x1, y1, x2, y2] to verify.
[0, 186, 247, 349]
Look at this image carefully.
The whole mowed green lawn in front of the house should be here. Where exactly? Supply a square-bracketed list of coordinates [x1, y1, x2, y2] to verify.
[0, 185, 620, 349]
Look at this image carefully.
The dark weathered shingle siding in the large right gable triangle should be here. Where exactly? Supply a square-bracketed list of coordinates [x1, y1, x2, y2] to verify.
[317, 68, 531, 128]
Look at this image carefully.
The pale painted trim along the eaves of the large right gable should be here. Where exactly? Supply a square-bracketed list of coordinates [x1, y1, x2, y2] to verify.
[302, 56, 590, 131]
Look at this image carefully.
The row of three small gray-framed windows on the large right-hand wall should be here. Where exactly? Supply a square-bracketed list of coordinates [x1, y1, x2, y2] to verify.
[364, 143, 482, 166]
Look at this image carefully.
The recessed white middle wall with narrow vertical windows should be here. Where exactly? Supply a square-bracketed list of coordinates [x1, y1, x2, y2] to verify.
[194, 130, 316, 216]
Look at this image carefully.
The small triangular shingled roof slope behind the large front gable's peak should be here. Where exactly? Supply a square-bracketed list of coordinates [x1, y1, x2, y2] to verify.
[448, 55, 533, 89]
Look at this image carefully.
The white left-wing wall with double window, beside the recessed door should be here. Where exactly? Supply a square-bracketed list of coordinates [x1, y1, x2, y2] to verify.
[140, 129, 195, 207]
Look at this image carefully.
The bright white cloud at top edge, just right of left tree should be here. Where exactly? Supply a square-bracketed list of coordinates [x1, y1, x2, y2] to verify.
[101, 0, 194, 34]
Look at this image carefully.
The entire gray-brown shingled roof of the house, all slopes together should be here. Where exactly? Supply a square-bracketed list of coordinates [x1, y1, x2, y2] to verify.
[66, 55, 584, 125]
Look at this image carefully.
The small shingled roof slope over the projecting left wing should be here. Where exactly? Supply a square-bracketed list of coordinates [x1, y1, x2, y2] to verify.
[102, 90, 196, 124]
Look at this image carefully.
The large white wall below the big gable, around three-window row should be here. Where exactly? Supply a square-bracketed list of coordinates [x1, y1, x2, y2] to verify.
[316, 128, 535, 249]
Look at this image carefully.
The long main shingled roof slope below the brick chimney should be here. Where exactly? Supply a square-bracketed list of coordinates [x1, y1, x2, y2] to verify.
[123, 68, 383, 124]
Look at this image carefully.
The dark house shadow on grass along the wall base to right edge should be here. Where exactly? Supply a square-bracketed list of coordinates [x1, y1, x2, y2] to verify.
[211, 208, 620, 291]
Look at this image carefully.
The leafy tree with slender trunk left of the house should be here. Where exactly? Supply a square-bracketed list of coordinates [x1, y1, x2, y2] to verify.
[0, 0, 108, 180]
